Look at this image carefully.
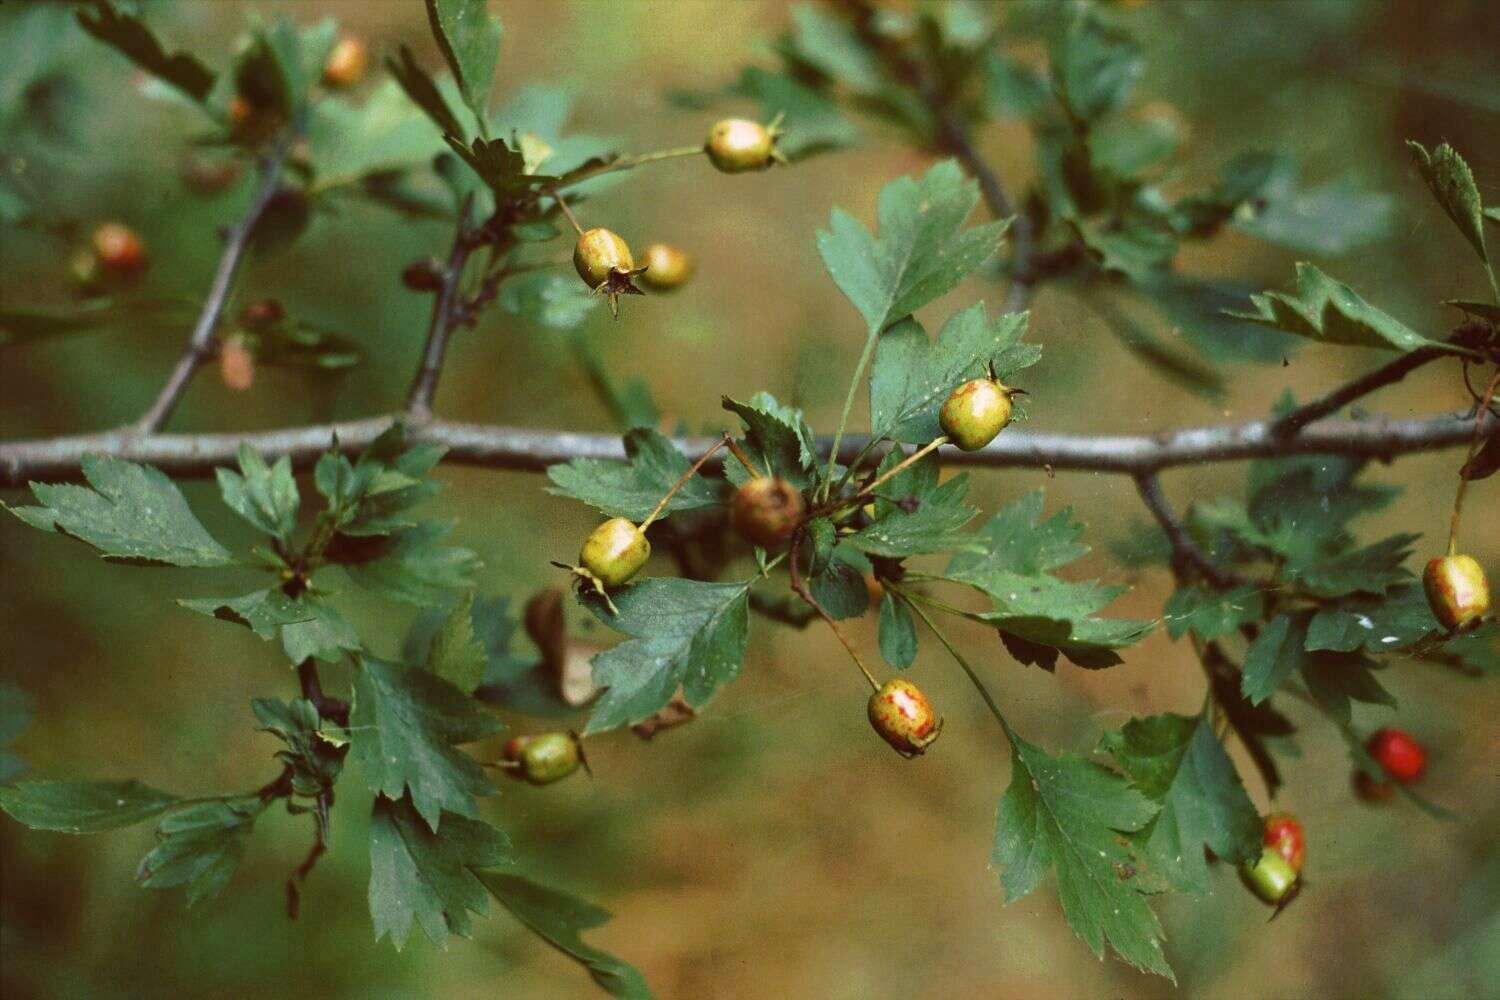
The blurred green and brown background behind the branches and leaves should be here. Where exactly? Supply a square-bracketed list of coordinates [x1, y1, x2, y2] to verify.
[0, 0, 1500, 997]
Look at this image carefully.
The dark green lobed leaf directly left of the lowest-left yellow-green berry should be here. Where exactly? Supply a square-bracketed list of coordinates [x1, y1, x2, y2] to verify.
[350, 657, 504, 832]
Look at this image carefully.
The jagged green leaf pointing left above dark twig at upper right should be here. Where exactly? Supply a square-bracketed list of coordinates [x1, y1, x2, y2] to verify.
[1229, 262, 1461, 352]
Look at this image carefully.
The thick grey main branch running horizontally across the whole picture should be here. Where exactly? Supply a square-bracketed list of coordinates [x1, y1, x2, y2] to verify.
[0, 414, 1500, 487]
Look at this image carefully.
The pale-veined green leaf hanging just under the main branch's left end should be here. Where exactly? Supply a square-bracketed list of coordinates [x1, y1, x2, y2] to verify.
[9, 454, 234, 567]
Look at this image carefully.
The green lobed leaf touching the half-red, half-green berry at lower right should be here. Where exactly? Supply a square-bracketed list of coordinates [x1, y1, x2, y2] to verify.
[1100, 715, 1262, 894]
